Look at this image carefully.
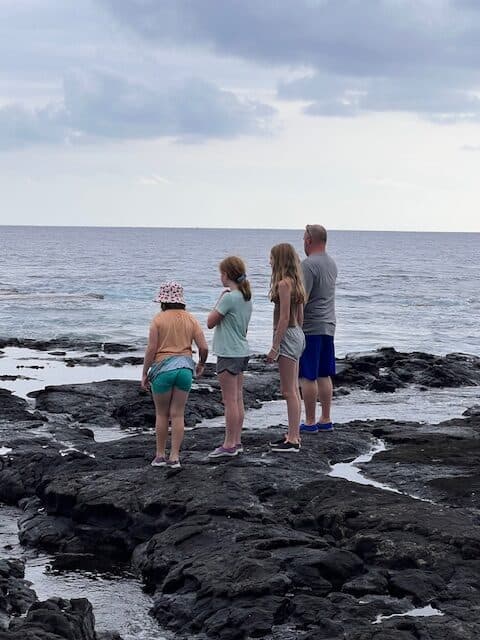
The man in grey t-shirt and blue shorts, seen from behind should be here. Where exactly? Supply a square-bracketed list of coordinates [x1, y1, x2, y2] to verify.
[299, 224, 337, 433]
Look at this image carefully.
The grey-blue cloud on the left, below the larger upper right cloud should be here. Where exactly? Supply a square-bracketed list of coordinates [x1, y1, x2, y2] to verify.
[0, 71, 274, 149]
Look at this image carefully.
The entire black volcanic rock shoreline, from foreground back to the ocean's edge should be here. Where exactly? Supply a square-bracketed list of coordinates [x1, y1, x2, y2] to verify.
[0, 343, 480, 640]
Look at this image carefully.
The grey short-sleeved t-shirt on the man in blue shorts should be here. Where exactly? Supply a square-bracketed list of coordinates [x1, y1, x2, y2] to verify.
[302, 253, 337, 336]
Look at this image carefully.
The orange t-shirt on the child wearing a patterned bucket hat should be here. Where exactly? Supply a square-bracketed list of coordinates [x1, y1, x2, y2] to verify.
[152, 309, 203, 362]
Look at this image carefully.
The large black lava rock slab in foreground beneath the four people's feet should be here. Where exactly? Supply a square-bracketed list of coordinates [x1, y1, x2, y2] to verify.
[0, 412, 480, 640]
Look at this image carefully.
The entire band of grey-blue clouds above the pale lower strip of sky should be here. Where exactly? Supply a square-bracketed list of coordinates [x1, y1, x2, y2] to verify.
[0, 0, 480, 150]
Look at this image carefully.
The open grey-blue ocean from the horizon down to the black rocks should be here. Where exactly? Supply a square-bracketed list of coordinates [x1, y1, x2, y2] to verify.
[0, 227, 480, 355]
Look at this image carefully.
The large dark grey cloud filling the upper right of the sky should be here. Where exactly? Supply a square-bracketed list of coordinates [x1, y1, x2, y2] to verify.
[102, 0, 480, 122]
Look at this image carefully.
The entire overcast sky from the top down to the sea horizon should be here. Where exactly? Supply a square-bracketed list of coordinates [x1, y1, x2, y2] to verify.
[0, 0, 480, 232]
